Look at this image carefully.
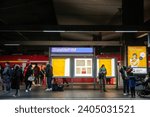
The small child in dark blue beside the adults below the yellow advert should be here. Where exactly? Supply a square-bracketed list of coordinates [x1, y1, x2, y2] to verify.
[129, 76, 136, 98]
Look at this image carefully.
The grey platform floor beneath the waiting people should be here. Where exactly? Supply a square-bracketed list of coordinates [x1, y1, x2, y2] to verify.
[0, 86, 150, 100]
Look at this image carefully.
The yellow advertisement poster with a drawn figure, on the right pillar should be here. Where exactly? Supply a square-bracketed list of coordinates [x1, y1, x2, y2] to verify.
[128, 46, 147, 74]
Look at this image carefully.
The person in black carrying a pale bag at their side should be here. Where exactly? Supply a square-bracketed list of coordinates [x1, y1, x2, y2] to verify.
[25, 64, 33, 92]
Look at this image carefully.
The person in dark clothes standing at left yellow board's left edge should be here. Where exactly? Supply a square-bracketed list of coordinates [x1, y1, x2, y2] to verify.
[45, 64, 53, 91]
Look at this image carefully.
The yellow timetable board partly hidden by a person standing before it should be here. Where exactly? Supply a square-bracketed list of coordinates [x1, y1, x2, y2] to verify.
[97, 59, 115, 77]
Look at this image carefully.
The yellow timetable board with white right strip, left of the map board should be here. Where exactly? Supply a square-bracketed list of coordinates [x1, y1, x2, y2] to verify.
[52, 58, 70, 77]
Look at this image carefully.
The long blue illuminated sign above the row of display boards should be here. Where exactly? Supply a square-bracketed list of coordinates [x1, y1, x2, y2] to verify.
[51, 47, 93, 54]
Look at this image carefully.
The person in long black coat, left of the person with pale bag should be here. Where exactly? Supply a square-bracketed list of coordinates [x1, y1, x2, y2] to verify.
[11, 65, 21, 97]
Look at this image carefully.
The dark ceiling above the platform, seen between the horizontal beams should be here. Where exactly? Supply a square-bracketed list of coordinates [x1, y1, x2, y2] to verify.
[0, 0, 150, 54]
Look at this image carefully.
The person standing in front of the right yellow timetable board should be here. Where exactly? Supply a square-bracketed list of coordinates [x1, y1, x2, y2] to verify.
[99, 64, 107, 92]
